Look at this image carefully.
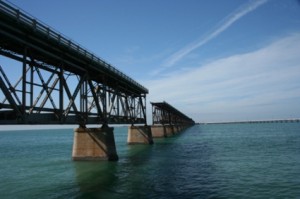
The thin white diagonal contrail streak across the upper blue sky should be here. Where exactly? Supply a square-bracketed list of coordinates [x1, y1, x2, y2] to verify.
[161, 0, 268, 70]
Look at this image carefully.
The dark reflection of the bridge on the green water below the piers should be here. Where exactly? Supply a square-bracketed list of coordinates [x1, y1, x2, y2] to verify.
[75, 128, 220, 198]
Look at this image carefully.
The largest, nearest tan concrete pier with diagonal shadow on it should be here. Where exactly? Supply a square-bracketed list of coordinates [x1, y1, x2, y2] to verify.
[72, 125, 119, 161]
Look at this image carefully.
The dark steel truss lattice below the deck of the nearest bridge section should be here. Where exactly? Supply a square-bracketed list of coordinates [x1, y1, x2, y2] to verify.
[0, 46, 146, 126]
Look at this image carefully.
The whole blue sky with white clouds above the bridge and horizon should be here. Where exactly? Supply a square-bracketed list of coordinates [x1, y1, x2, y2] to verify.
[3, 0, 300, 122]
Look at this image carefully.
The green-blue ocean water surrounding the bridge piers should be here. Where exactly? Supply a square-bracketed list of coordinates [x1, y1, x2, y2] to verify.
[0, 123, 300, 199]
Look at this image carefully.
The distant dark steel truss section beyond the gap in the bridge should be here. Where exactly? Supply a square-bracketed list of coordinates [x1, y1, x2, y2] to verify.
[151, 102, 195, 125]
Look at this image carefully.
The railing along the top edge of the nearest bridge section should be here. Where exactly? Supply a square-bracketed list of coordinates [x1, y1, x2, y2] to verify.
[0, 1, 148, 93]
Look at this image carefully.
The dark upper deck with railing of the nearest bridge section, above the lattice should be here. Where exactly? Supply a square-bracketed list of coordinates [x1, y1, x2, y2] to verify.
[0, 1, 148, 94]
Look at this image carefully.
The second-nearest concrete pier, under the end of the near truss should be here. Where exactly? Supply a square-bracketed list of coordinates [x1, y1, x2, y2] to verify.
[127, 125, 153, 144]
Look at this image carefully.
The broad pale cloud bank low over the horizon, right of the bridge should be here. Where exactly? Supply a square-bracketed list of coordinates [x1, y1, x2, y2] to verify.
[144, 33, 300, 121]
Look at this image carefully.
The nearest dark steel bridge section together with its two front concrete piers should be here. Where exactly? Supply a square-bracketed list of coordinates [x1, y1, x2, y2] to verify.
[0, 1, 195, 160]
